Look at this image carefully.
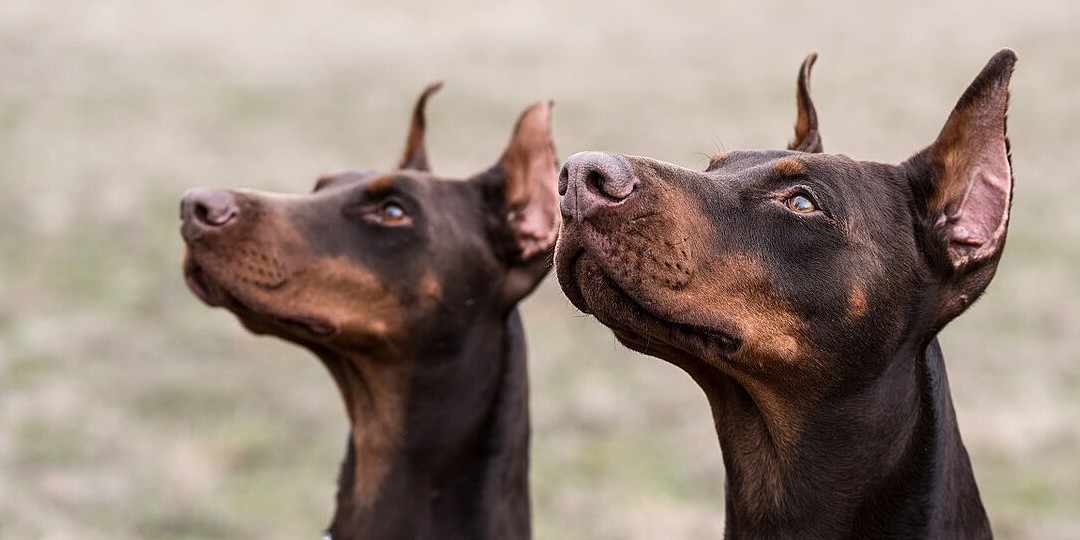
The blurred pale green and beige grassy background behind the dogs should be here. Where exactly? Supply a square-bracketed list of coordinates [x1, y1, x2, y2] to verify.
[0, 0, 1080, 540]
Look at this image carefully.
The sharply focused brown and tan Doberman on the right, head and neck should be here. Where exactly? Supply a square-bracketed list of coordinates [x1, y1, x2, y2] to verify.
[555, 50, 1016, 539]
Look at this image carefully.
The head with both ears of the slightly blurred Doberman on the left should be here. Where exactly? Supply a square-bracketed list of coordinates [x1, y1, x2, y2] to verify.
[180, 84, 557, 356]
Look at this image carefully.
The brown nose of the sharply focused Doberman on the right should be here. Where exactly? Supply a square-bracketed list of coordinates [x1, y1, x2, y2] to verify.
[558, 152, 638, 219]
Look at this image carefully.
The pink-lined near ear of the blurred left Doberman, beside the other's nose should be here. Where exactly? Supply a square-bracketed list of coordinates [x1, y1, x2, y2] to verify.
[482, 102, 558, 301]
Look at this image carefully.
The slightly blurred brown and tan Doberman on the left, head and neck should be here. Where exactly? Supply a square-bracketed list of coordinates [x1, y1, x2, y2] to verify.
[180, 83, 558, 540]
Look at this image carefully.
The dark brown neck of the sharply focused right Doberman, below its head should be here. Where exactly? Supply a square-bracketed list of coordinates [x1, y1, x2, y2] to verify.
[691, 338, 990, 539]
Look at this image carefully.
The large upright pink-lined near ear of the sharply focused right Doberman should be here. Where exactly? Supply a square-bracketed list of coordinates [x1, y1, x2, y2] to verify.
[907, 49, 1016, 321]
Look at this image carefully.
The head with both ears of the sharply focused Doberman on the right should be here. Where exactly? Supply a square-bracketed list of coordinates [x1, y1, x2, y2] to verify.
[555, 50, 1016, 390]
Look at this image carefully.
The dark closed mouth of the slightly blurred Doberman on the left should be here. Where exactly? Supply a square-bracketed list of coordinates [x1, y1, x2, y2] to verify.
[184, 251, 338, 338]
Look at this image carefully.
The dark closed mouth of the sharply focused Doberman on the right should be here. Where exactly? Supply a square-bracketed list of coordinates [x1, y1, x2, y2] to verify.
[558, 247, 742, 360]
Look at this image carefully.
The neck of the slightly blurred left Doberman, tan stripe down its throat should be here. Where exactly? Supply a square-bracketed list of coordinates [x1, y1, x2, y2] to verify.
[318, 310, 531, 539]
